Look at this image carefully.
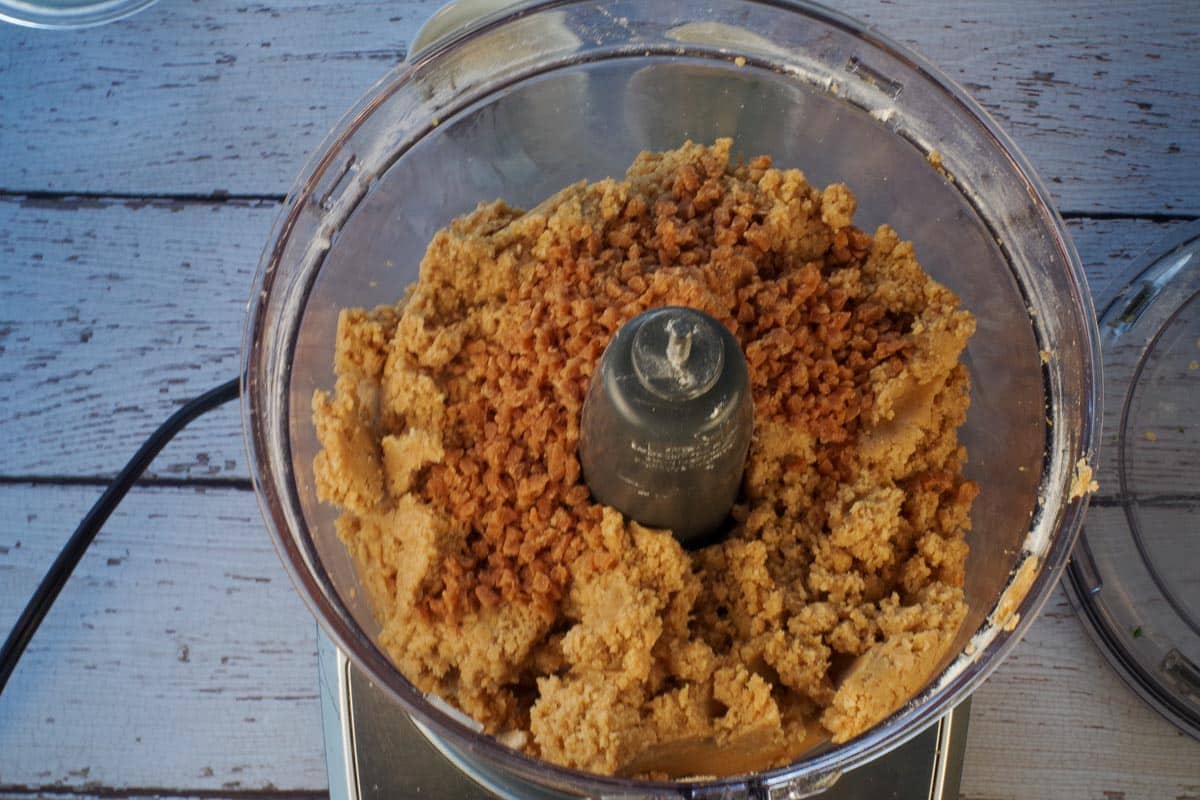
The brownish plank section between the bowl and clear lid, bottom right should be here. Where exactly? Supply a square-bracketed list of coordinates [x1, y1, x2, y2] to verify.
[961, 589, 1200, 800]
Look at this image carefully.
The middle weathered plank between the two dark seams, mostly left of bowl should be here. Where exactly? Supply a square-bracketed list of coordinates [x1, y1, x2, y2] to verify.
[0, 198, 1180, 479]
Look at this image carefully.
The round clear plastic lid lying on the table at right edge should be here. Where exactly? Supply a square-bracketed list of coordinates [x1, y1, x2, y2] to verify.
[1066, 222, 1200, 739]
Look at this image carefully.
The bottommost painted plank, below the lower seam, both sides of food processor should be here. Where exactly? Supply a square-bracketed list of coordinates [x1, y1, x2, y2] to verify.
[0, 486, 1200, 800]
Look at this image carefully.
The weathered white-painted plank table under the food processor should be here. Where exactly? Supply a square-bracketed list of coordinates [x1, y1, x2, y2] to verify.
[0, 0, 1200, 800]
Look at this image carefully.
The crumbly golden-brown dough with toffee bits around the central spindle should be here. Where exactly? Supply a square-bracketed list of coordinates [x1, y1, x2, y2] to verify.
[313, 140, 978, 777]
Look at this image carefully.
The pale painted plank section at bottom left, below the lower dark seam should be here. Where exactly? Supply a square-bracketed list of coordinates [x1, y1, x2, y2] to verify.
[0, 486, 325, 793]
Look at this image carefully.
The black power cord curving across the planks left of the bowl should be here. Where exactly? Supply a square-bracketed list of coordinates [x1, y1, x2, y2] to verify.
[0, 379, 239, 692]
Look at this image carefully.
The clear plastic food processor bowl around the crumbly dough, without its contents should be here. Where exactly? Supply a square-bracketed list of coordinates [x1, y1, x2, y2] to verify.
[242, 0, 1099, 798]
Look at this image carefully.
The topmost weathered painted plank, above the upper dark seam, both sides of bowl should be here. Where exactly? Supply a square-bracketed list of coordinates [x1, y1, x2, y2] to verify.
[0, 0, 1200, 213]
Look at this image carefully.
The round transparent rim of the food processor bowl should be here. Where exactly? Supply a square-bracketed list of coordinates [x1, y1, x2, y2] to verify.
[241, 0, 1102, 793]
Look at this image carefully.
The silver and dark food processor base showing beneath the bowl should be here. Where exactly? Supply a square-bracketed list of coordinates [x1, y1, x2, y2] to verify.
[318, 632, 971, 800]
